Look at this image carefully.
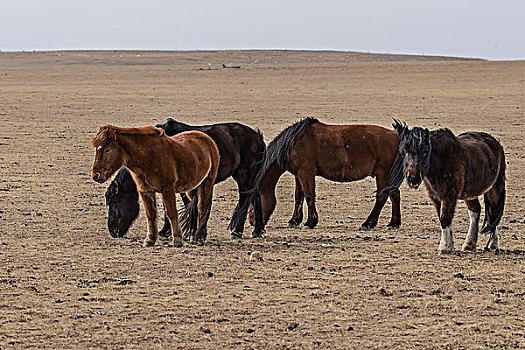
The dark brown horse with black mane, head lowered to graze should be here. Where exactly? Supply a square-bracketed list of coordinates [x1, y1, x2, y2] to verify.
[239, 118, 401, 229]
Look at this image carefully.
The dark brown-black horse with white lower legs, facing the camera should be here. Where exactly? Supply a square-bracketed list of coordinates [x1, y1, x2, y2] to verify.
[382, 119, 505, 254]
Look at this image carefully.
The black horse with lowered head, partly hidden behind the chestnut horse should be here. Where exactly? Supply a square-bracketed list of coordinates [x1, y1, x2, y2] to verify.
[106, 118, 266, 238]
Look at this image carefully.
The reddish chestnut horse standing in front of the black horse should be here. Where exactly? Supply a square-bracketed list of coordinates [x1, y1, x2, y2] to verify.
[91, 125, 220, 247]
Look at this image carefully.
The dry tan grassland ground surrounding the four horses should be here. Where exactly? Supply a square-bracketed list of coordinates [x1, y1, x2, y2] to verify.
[0, 51, 525, 349]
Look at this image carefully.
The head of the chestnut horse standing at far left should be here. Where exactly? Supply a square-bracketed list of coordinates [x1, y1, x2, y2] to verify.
[91, 125, 126, 183]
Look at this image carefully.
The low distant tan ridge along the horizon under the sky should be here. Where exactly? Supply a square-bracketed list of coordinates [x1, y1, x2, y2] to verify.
[0, 50, 485, 68]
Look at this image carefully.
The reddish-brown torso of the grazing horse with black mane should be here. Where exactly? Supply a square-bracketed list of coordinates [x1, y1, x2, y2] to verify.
[287, 123, 398, 182]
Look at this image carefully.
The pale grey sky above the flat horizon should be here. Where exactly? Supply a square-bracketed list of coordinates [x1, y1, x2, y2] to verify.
[0, 0, 525, 59]
